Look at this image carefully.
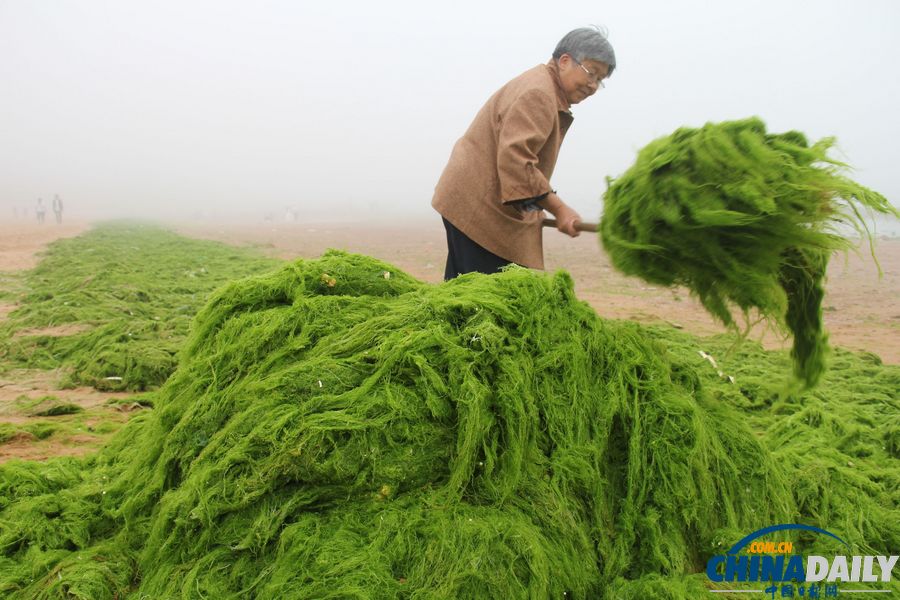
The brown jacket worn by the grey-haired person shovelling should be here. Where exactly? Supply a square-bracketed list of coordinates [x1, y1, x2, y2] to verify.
[431, 60, 573, 269]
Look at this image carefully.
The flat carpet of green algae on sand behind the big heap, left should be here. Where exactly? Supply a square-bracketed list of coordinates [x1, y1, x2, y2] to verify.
[0, 222, 278, 391]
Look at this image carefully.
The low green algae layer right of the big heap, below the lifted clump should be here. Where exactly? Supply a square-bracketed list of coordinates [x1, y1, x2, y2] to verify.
[646, 327, 900, 564]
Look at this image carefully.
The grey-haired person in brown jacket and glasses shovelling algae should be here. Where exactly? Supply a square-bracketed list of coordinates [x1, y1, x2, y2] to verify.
[431, 28, 616, 279]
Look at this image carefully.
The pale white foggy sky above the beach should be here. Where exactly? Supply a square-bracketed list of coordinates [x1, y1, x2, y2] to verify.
[0, 0, 900, 221]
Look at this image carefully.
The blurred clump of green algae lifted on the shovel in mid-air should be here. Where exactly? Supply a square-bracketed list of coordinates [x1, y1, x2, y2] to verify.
[600, 118, 898, 387]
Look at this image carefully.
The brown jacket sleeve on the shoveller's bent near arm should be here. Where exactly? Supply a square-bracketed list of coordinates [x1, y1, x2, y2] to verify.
[497, 90, 558, 204]
